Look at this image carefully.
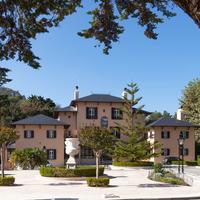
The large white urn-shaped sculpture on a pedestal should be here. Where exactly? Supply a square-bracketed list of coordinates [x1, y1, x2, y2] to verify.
[65, 138, 80, 168]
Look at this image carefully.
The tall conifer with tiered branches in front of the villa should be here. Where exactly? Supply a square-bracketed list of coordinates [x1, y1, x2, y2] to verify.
[114, 83, 159, 162]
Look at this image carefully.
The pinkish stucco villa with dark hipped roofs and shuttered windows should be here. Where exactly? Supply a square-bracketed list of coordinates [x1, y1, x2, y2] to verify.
[13, 87, 195, 166]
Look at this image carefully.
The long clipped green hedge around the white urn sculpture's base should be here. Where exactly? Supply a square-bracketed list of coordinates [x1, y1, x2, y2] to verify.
[40, 166, 104, 177]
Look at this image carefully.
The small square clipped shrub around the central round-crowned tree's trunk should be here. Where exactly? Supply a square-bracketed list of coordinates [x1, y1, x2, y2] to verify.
[86, 177, 110, 187]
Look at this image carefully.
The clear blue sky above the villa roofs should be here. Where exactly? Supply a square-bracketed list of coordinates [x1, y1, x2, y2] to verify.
[3, 3, 200, 114]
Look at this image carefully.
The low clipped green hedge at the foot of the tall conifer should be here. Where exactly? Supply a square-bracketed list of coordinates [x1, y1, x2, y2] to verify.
[112, 161, 154, 167]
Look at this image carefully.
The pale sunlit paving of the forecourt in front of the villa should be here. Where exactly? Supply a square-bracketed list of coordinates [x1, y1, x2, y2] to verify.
[0, 168, 200, 200]
